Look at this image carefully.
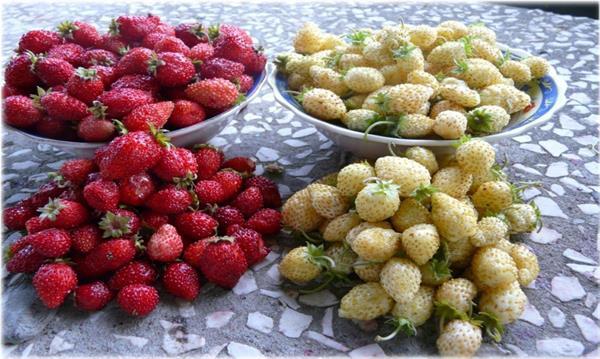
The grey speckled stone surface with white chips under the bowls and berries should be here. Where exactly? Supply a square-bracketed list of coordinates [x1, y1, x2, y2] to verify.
[2, 2, 600, 357]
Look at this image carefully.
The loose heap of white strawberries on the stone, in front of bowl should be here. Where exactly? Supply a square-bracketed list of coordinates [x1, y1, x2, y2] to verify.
[279, 138, 540, 356]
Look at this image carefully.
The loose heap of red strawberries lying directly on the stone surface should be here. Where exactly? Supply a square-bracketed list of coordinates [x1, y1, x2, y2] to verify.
[3, 130, 281, 315]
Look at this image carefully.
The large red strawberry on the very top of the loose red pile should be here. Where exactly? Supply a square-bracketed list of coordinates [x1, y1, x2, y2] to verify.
[96, 131, 168, 179]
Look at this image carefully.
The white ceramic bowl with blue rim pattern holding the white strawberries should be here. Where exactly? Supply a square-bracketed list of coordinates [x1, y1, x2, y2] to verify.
[268, 44, 567, 158]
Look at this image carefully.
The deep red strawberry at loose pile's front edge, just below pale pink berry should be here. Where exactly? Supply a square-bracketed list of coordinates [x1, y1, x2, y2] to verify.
[163, 262, 200, 301]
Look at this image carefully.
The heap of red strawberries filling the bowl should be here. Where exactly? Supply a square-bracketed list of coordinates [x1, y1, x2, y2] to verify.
[2, 15, 267, 142]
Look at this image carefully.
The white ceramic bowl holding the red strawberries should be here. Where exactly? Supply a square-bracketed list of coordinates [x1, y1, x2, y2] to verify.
[4, 66, 272, 158]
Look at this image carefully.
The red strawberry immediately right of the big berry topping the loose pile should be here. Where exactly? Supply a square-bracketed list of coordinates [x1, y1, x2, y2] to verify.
[152, 147, 198, 182]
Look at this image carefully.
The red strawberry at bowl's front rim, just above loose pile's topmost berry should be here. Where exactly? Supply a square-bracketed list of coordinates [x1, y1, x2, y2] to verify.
[123, 101, 174, 131]
